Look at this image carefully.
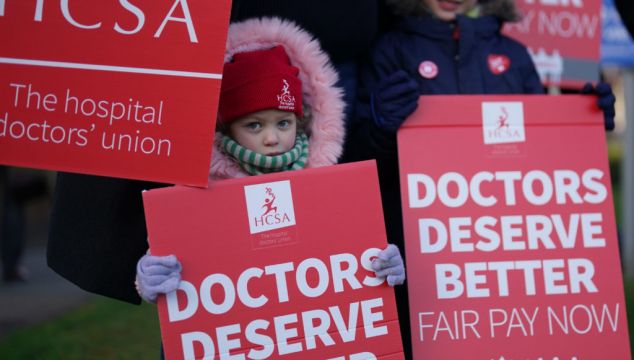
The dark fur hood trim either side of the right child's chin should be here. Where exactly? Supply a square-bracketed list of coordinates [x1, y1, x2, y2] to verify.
[386, 0, 522, 22]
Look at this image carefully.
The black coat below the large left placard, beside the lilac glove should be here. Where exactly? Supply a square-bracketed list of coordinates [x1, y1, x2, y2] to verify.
[47, 173, 160, 304]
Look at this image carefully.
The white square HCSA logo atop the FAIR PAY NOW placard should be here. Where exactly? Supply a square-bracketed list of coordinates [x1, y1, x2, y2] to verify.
[482, 101, 526, 144]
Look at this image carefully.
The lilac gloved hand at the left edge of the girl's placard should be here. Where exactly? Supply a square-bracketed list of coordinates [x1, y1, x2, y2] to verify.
[136, 254, 181, 303]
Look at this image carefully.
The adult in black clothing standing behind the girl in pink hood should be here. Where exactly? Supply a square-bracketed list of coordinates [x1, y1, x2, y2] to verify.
[47, 0, 380, 304]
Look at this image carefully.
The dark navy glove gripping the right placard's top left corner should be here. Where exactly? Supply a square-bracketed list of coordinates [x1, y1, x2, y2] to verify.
[372, 70, 420, 132]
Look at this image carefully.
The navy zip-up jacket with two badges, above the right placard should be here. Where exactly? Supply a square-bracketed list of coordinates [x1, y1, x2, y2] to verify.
[378, 16, 542, 95]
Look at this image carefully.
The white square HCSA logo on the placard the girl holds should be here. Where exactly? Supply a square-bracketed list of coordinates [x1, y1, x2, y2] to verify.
[244, 180, 295, 234]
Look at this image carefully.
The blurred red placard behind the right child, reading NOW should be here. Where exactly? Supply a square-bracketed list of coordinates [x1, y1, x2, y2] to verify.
[504, 0, 601, 88]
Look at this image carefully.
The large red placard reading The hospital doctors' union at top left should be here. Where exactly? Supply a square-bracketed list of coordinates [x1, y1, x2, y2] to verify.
[0, 0, 231, 186]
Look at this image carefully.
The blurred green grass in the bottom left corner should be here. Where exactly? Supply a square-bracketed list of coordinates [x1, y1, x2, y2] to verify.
[0, 298, 161, 360]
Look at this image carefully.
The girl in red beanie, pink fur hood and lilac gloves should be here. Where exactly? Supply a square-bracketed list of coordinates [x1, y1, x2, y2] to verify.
[137, 19, 405, 302]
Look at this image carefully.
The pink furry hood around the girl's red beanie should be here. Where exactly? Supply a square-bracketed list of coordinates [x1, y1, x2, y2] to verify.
[209, 18, 345, 179]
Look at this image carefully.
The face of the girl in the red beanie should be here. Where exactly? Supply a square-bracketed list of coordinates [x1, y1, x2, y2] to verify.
[229, 109, 297, 156]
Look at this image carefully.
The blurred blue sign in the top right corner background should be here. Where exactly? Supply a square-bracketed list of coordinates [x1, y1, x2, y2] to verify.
[601, 0, 634, 67]
